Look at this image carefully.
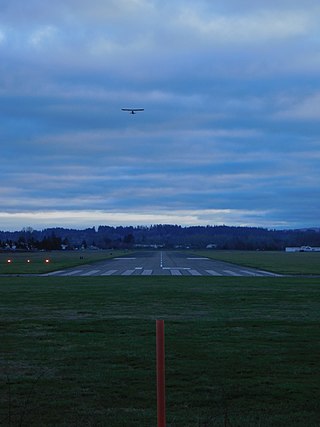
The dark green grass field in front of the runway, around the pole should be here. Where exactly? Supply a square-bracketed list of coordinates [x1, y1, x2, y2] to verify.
[0, 277, 320, 427]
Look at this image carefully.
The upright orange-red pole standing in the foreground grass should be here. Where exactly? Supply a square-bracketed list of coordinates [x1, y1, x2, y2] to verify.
[156, 320, 166, 427]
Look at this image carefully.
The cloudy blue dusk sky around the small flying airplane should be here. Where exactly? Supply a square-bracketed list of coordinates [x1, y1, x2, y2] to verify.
[0, 0, 320, 230]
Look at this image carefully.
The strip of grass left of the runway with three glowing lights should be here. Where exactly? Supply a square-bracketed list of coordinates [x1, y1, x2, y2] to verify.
[0, 250, 128, 274]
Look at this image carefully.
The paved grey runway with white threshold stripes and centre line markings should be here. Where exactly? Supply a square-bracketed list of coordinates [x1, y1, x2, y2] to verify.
[44, 251, 279, 277]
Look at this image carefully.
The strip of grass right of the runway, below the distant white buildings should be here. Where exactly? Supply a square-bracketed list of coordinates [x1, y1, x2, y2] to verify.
[191, 250, 320, 275]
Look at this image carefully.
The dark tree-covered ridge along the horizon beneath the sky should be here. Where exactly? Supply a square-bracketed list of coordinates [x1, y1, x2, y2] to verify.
[0, 224, 320, 250]
